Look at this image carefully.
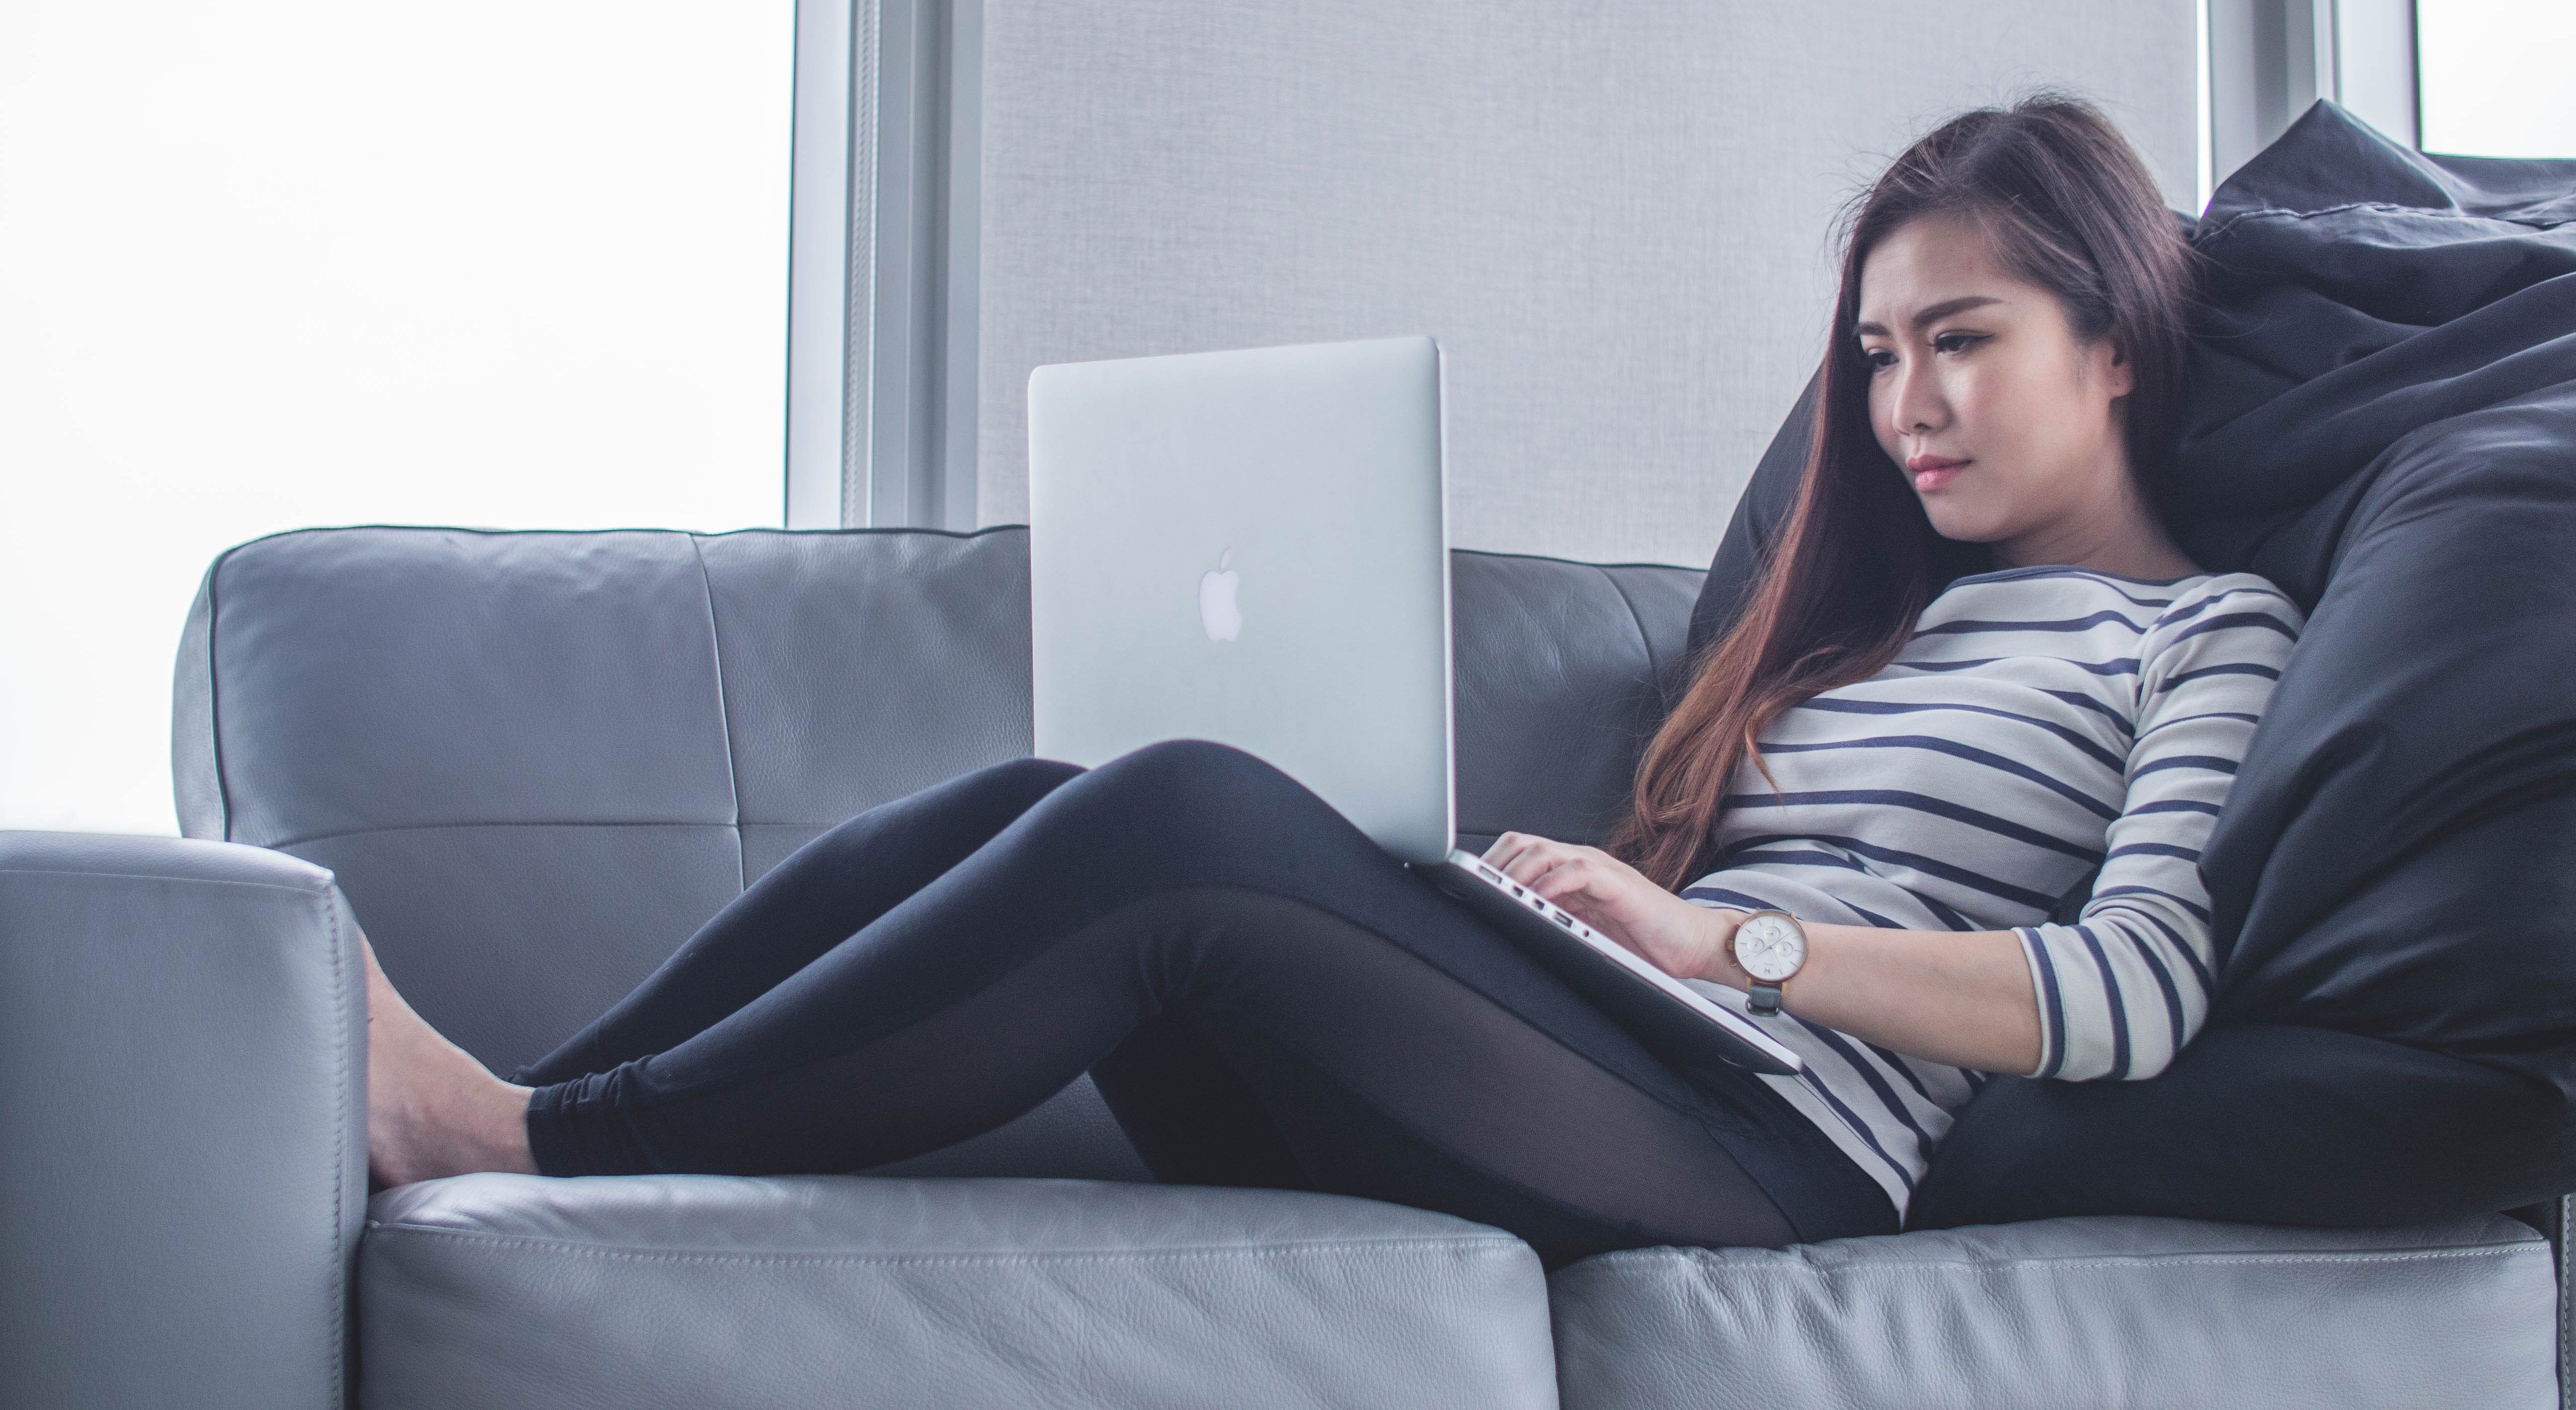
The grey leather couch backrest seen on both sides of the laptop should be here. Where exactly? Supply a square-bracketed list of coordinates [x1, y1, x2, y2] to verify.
[172, 529, 1700, 1070]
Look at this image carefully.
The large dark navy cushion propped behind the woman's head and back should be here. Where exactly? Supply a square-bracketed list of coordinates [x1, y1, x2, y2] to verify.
[1695, 103, 2576, 1227]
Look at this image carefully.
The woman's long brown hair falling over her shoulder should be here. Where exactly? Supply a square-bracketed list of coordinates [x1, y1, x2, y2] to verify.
[1610, 93, 2192, 887]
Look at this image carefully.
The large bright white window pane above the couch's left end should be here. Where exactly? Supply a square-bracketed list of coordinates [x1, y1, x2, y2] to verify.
[0, 0, 796, 833]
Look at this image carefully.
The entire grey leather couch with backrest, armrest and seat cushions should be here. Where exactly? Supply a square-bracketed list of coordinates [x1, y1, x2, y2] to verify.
[0, 529, 2561, 1410]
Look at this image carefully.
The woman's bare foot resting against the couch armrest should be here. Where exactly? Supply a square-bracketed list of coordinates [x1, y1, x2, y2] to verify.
[358, 936, 536, 1186]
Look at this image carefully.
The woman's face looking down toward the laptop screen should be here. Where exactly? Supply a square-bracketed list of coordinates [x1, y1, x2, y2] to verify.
[1854, 217, 2136, 567]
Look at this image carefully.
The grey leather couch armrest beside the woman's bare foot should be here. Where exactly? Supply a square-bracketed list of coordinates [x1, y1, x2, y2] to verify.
[0, 833, 366, 1410]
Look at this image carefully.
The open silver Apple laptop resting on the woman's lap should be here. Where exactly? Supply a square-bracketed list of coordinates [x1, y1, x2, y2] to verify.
[1028, 338, 1801, 1072]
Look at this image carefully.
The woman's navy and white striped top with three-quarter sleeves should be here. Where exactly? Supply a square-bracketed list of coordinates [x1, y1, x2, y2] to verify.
[1682, 567, 2303, 1214]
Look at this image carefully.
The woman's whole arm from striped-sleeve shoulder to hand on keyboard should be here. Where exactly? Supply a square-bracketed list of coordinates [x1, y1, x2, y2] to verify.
[1486, 580, 2303, 1080]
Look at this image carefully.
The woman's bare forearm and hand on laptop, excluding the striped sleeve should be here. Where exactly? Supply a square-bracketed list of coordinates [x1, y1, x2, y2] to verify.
[1484, 833, 2040, 1072]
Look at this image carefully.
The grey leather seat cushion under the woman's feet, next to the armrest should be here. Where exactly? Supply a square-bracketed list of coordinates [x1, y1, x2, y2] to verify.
[358, 1175, 1556, 1410]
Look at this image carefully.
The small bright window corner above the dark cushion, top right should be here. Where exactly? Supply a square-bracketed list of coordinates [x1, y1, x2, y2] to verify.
[2416, 0, 2576, 157]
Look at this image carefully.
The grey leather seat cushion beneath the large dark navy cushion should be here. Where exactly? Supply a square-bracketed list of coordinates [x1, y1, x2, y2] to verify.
[1553, 1214, 2558, 1410]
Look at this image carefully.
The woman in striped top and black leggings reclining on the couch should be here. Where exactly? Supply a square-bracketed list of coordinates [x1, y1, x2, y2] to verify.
[368, 98, 2300, 1263]
